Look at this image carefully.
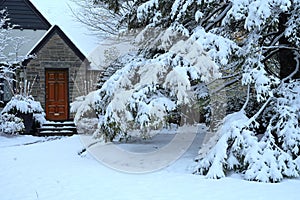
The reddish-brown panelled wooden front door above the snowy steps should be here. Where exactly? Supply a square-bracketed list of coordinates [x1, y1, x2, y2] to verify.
[46, 69, 69, 120]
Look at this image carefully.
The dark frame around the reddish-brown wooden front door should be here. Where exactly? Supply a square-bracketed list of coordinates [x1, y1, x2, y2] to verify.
[45, 68, 70, 121]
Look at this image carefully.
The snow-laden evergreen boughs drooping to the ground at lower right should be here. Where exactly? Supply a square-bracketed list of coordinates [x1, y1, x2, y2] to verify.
[197, 77, 300, 182]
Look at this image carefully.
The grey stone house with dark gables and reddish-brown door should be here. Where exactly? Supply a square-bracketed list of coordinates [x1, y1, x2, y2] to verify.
[0, 0, 89, 121]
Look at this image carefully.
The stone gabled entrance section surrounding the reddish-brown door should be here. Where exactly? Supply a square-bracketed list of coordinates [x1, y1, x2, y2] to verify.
[23, 25, 88, 120]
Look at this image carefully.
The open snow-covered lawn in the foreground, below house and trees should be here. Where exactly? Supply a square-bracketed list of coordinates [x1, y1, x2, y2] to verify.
[0, 135, 300, 200]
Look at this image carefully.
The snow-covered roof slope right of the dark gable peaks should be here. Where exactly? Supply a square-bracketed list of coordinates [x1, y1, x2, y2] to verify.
[30, 0, 101, 57]
